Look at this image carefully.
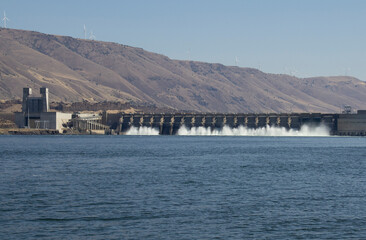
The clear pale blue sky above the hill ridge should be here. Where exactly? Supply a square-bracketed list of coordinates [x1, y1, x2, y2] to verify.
[0, 0, 366, 80]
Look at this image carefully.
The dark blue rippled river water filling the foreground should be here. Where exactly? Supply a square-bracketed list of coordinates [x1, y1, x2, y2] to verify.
[0, 136, 366, 239]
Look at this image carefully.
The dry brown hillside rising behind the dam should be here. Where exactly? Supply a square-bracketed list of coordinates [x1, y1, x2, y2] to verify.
[0, 29, 366, 112]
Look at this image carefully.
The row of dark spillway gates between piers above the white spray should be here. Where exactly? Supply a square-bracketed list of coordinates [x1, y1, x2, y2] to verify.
[116, 113, 339, 135]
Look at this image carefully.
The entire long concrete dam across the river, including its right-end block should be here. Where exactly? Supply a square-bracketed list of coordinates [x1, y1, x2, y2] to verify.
[103, 110, 366, 136]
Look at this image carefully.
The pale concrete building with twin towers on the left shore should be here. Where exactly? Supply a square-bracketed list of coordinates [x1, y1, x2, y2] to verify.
[15, 87, 72, 130]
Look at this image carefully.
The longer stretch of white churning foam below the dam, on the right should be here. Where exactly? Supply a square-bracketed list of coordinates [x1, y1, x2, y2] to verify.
[177, 125, 330, 137]
